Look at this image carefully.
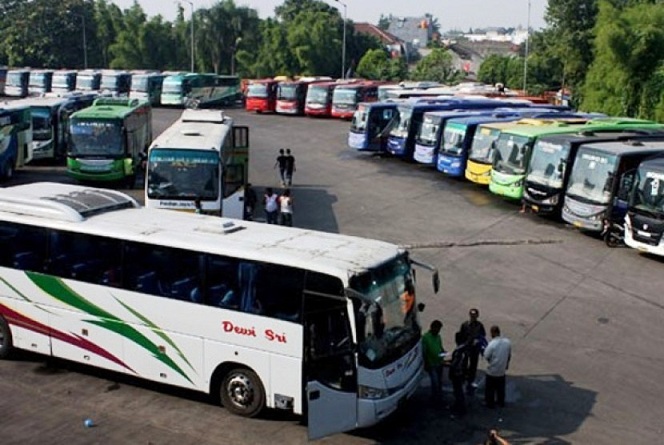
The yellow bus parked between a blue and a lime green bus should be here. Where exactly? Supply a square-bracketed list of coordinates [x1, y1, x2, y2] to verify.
[464, 118, 586, 186]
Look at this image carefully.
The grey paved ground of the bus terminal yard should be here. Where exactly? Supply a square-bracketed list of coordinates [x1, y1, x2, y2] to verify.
[0, 109, 664, 444]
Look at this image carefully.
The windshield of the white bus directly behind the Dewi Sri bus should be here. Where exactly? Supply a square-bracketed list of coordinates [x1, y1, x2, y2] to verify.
[147, 149, 220, 200]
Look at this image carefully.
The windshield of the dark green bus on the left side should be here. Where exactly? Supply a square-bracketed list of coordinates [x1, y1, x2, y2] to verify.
[69, 119, 124, 156]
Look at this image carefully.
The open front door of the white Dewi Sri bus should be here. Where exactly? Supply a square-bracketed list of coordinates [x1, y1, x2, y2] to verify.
[303, 278, 357, 440]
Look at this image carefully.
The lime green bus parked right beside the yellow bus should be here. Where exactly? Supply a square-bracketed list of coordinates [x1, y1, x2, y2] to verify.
[489, 117, 664, 200]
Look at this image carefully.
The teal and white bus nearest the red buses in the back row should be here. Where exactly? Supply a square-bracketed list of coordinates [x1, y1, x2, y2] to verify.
[161, 73, 242, 108]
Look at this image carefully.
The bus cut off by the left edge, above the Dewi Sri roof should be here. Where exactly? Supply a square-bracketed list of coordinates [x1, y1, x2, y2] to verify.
[0, 104, 32, 180]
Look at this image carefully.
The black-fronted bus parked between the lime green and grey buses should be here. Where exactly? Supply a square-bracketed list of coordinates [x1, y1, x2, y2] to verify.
[521, 130, 664, 217]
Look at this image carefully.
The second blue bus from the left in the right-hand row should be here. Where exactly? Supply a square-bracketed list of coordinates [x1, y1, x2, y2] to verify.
[387, 97, 536, 160]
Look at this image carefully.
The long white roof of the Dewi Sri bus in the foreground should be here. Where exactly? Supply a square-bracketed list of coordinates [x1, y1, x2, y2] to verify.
[0, 183, 403, 280]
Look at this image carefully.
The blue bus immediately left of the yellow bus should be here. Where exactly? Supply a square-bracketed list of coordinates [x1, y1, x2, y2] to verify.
[435, 112, 584, 178]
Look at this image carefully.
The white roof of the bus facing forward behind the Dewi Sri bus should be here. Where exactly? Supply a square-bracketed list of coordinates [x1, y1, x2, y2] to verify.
[150, 110, 233, 152]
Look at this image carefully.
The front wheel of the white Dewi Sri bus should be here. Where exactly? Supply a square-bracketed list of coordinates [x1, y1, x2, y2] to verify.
[220, 368, 265, 417]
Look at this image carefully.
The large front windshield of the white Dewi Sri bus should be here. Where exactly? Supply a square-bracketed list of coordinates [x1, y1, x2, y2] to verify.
[350, 255, 420, 369]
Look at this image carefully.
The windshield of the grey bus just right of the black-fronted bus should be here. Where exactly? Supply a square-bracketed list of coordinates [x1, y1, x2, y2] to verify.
[567, 149, 618, 204]
